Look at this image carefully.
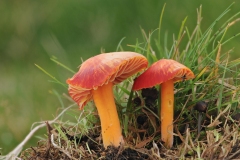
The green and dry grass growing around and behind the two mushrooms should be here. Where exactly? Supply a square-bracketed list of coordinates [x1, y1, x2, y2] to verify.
[1, 2, 240, 159]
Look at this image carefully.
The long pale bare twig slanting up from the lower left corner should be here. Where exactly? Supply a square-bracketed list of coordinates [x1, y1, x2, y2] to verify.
[0, 104, 75, 160]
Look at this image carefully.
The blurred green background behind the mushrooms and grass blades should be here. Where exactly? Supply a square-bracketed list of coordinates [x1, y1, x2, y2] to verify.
[0, 0, 240, 154]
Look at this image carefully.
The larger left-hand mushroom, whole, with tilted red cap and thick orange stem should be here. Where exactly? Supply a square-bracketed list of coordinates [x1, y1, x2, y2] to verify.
[67, 52, 148, 148]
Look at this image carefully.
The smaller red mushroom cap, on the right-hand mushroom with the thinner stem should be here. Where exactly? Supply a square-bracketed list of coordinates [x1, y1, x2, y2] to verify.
[133, 59, 195, 90]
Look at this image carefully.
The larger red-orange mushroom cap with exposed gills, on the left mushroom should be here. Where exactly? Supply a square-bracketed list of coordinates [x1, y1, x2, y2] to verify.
[67, 52, 148, 109]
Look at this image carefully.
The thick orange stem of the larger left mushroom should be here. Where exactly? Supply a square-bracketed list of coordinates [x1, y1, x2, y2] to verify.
[92, 82, 123, 146]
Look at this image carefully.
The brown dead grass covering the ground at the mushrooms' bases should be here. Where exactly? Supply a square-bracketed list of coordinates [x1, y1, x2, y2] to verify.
[20, 102, 240, 160]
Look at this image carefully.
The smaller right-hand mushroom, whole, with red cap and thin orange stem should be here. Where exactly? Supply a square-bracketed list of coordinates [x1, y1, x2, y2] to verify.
[133, 59, 195, 148]
